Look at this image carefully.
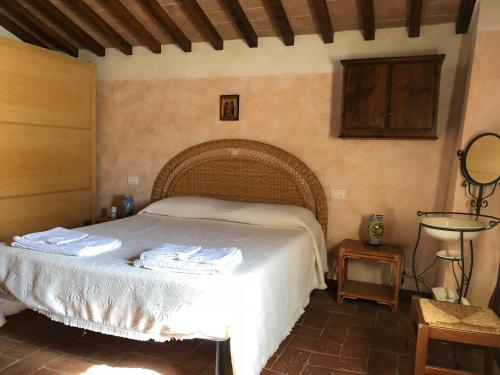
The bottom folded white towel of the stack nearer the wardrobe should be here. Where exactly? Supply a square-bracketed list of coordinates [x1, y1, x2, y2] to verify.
[12, 235, 122, 257]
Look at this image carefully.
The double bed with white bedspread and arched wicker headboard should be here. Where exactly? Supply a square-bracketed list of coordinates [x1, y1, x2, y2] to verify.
[0, 140, 327, 375]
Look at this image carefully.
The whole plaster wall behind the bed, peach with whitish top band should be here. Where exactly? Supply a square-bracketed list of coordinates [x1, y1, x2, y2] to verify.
[81, 24, 462, 288]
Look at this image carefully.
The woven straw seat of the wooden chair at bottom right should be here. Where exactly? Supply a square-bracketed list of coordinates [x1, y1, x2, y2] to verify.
[419, 298, 500, 335]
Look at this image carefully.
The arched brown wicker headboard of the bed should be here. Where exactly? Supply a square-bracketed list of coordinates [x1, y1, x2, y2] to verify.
[151, 139, 328, 238]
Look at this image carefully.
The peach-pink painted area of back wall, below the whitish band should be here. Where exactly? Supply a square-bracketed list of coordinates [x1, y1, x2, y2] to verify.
[97, 67, 460, 288]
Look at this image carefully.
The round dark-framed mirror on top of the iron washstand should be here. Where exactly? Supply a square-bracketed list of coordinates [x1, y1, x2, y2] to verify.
[461, 133, 500, 185]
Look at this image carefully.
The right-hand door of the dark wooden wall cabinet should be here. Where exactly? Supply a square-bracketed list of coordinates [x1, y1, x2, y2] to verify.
[388, 61, 439, 136]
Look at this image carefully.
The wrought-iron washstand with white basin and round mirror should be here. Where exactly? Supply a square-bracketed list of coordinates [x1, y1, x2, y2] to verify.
[412, 133, 500, 304]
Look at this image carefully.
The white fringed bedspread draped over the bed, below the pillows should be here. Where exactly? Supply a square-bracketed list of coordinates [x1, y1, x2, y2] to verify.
[0, 213, 324, 375]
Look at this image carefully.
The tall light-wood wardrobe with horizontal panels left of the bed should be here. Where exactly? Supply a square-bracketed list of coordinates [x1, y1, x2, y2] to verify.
[0, 38, 95, 240]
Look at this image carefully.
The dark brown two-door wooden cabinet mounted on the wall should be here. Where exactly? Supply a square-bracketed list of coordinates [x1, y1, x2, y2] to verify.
[340, 55, 445, 139]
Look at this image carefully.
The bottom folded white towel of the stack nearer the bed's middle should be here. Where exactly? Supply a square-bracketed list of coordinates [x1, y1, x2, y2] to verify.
[134, 247, 243, 274]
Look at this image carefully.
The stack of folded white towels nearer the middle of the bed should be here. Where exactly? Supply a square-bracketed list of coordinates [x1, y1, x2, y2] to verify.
[134, 243, 243, 275]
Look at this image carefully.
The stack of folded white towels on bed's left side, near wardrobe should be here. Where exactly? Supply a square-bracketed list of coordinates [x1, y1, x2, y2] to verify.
[12, 227, 122, 257]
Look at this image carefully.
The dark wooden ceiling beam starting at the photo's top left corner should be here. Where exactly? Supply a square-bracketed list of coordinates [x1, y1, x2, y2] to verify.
[0, 1, 78, 57]
